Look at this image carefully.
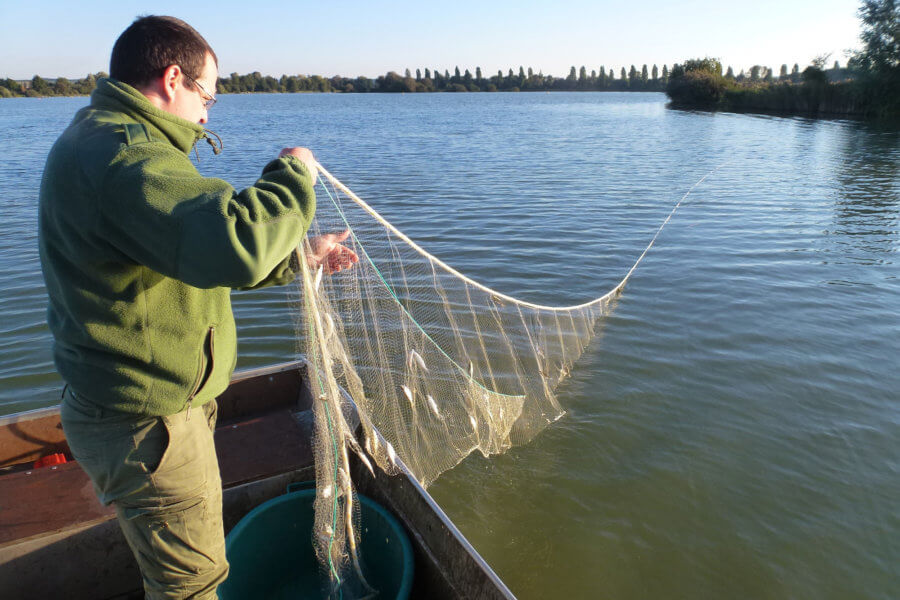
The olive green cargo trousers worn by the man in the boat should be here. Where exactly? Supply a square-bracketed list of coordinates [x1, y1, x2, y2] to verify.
[60, 388, 228, 600]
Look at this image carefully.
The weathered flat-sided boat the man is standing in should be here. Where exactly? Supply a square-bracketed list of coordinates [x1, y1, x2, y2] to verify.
[0, 360, 515, 600]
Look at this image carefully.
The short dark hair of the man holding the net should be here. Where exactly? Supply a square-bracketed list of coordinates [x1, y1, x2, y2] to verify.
[109, 15, 219, 87]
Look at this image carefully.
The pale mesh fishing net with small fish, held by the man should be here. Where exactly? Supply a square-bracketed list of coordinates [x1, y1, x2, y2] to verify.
[299, 161, 699, 593]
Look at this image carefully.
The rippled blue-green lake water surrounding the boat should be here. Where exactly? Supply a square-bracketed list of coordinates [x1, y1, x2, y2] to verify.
[0, 93, 900, 599]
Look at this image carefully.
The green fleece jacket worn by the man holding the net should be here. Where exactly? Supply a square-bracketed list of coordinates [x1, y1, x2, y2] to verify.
[39, 79, 315, 415]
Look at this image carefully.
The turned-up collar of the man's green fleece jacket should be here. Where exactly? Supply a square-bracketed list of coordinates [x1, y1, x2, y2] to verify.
[91, 77, 206, 154]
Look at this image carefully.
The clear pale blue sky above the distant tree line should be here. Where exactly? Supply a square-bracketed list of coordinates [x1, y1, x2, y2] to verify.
[0, 0, 859, 79]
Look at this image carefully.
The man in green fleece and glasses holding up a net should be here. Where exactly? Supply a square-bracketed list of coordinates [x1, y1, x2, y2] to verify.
[39, 17, 357, 598]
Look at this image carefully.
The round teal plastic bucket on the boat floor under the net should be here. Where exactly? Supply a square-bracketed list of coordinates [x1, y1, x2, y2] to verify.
[219, 488, 413, 600]
